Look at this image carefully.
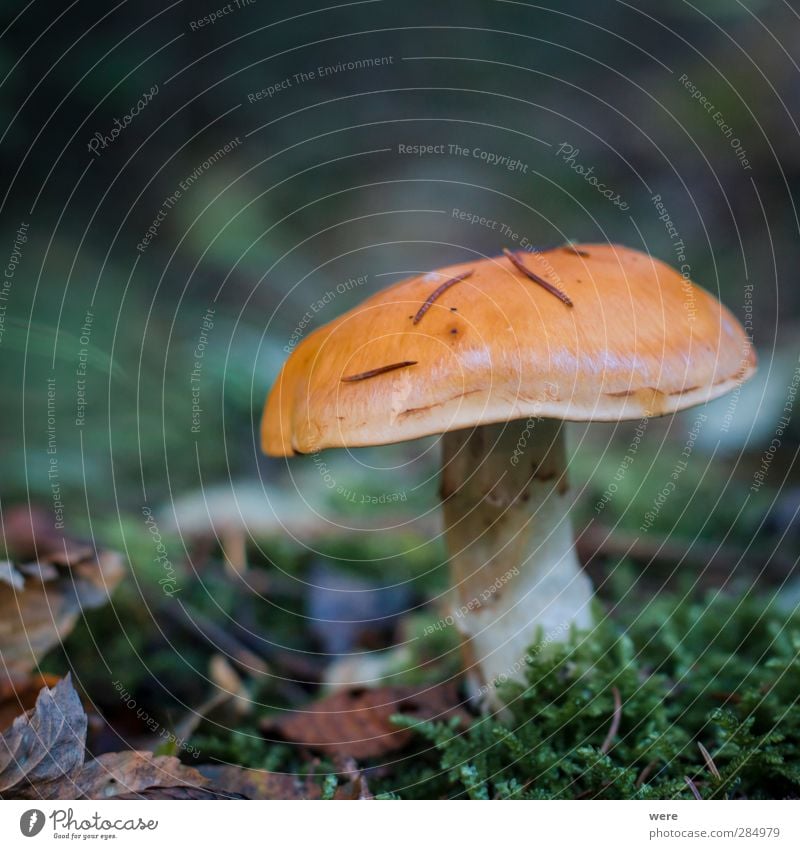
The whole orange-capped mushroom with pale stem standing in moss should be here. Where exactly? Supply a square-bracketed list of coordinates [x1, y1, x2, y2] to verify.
[261, 244, 756, 705]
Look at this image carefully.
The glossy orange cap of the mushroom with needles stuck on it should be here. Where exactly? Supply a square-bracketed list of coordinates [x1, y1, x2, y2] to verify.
[261, 245, 756, 456]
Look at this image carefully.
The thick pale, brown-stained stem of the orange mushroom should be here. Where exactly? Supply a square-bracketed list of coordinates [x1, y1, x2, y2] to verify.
[442, 419, 592, 707]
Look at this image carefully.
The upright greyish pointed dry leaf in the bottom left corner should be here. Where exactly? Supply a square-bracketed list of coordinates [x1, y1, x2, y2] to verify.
[0, 675, 86, 796]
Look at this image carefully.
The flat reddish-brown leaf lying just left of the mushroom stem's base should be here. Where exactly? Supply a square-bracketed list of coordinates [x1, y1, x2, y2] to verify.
[262, 684, 468, 759]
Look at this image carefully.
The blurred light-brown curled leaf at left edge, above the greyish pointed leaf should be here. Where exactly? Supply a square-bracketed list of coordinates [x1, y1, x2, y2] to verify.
[0, 548, 125, 685]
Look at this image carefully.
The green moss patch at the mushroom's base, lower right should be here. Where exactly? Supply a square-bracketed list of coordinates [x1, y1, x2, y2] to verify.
[376, 596, 800, 799]
